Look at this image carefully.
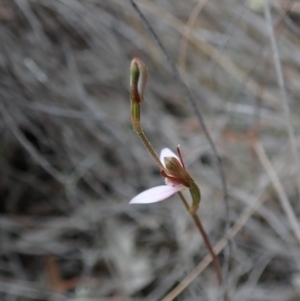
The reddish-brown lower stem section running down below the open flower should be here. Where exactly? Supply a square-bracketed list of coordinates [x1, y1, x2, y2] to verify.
[178, 192, 223, 285]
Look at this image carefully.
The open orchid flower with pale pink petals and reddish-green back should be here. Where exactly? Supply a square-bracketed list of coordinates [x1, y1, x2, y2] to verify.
[130, 147, 200, 206]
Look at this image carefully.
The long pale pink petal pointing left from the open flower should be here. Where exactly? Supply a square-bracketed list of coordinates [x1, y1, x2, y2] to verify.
[129, 185, 183, 204]
